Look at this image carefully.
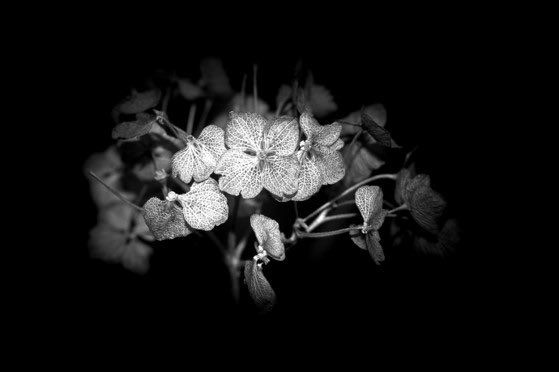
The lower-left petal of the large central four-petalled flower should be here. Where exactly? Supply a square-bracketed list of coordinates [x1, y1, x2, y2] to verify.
[215, 150, 262, 199]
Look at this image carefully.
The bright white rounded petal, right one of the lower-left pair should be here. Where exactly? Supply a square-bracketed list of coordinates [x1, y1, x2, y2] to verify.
[182, 178, 229, 231]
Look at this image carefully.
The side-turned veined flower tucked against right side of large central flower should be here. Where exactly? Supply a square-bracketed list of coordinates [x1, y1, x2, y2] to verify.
[293, 111, 345, 201]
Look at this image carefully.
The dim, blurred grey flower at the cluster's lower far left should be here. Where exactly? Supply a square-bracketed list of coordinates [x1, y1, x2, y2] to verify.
[89, 202, 153, 274]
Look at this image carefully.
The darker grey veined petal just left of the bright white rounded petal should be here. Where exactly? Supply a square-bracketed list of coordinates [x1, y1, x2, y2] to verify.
[143, 197, 191, 240]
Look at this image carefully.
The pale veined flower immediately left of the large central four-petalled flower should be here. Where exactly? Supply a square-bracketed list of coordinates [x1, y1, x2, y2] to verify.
[171, 125, 230, 183]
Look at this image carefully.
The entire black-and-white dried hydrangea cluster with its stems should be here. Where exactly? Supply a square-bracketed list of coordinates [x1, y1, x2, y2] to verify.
[85, 59, 459, 311]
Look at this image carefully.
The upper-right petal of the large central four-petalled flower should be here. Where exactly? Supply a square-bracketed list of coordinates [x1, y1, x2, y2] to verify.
[264, 116, 299, 156]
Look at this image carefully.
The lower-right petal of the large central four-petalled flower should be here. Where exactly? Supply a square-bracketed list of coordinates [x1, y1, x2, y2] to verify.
[262, 154, 300, 196]
